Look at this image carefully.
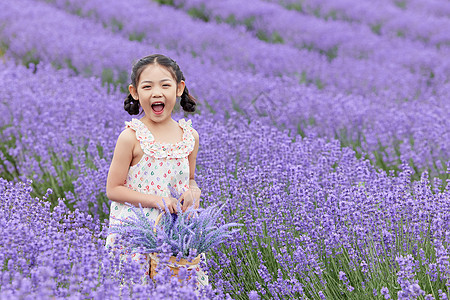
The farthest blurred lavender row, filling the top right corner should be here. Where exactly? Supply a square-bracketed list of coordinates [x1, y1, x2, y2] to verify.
[264, 0, 450, 47]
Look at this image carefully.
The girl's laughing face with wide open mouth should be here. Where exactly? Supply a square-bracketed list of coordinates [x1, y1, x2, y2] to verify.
[129, 64, 185, 123]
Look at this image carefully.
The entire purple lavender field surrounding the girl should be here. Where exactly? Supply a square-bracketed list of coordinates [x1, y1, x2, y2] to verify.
[0, 0, 450, 299]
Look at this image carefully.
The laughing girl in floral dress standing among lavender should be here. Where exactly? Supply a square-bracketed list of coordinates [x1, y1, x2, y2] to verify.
[106, 54, 208, 285]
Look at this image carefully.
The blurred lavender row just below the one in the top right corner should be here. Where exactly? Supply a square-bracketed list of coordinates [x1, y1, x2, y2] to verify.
[167, 0, 450, 69]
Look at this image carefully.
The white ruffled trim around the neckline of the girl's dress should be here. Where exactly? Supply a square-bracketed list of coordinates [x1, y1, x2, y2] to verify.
[125, 118, 195, 158]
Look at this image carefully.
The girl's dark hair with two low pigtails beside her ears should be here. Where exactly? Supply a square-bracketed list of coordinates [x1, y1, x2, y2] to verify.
[123, 54, 197, 115]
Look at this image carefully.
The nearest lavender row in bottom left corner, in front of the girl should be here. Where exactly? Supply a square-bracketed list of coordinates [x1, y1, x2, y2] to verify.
[0, 178, 215, 299]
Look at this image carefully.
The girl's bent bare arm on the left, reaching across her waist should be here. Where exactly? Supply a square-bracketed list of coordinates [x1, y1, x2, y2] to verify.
[106, 128, 169, 209]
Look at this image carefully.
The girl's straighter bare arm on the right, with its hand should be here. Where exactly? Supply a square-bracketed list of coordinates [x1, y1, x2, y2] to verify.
[180, 129, 201, 211]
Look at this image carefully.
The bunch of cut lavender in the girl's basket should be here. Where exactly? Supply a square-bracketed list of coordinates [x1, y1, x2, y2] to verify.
[110, 187, 242, 259]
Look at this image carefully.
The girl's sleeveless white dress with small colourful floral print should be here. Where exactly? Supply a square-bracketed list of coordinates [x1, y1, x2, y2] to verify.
[106, 119, 208, 285]
